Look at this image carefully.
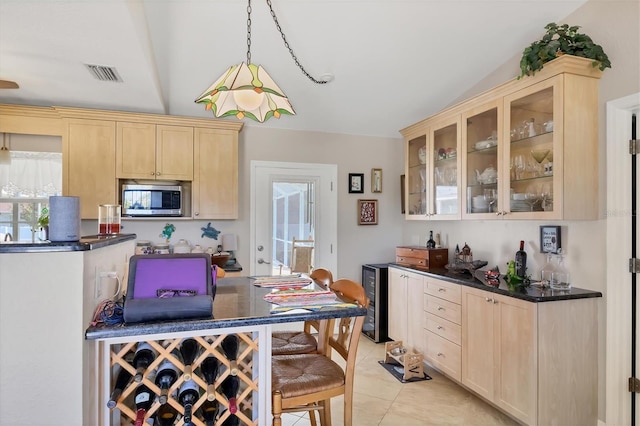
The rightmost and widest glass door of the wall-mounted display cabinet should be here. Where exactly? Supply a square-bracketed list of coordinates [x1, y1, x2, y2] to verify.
[501, 79, 562, 219]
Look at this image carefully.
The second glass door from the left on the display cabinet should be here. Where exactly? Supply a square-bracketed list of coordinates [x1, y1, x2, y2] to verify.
[427, 115, 461, 219]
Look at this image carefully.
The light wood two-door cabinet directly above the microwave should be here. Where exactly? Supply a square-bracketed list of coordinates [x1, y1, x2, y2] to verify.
[116, 122, 193, 181]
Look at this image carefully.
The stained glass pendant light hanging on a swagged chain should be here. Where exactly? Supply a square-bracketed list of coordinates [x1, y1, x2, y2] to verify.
[195, 0, 330, 123]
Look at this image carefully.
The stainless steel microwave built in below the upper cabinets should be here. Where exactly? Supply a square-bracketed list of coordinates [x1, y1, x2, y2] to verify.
[122, 185, 182, 217]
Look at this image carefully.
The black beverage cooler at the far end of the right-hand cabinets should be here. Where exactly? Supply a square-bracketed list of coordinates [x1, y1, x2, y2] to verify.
[362, 263, 389, 342]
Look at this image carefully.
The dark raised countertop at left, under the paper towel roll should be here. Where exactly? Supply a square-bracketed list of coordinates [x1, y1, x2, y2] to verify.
[0, 234, 136, 254]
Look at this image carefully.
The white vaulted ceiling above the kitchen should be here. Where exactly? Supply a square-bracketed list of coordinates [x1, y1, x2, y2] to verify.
[0, 0, 585, 137]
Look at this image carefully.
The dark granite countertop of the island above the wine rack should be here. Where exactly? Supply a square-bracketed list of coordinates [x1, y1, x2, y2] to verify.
[85, 277, 367, 340]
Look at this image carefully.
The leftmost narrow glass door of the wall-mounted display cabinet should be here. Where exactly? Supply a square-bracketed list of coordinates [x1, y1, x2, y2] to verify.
[404, 135, 427, 220]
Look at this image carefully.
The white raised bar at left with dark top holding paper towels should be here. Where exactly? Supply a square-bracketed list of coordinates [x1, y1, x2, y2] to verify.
[0, 234, 136, 426]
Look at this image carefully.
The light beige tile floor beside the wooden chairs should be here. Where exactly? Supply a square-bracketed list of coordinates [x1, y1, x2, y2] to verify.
[282, 336, 517, 426]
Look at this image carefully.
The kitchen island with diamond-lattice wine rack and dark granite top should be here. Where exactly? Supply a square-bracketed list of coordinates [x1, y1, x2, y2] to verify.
[86, 277, 366, 425]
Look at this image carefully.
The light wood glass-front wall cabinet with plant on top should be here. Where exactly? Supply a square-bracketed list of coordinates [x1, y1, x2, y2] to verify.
[401, 55, 602, 220]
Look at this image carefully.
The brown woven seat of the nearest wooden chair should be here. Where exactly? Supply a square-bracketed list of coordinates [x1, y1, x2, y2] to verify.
[271, 354, 345, 398]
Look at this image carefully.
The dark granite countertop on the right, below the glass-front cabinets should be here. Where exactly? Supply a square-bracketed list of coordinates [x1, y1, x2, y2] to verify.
[389, 263, 602, 302]
